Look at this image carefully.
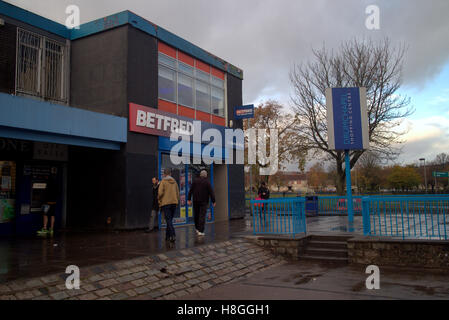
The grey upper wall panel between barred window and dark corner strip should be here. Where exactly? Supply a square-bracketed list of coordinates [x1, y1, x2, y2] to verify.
[70, 26, 128, 117]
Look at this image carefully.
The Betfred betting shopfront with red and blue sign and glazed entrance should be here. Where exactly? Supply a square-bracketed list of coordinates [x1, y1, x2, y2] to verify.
[129, 103, 229, 226]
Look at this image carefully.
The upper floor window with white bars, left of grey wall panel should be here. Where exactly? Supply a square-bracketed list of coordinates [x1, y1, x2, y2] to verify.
[16, 29, 67, 102]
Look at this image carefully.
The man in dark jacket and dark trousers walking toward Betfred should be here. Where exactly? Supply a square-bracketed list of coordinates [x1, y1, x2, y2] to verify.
[187, 170, 215, 236]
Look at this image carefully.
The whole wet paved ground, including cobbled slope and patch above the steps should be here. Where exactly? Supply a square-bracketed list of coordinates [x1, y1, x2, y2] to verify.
[0, 216, 449, 300]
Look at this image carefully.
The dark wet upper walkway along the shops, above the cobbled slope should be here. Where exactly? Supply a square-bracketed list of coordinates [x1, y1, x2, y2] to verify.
[0, 219, 251, 283]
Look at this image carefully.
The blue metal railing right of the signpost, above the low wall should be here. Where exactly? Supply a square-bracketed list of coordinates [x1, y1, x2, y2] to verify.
[362, 195, 449, 240]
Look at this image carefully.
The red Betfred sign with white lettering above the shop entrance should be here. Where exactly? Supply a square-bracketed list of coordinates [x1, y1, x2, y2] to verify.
[129, 103, 193, 137]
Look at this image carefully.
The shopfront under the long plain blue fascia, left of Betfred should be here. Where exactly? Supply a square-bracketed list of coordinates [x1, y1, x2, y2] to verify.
[0, 93, 127, 236]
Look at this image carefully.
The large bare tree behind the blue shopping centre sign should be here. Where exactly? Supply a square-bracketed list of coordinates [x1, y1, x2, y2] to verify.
[290, 39, 413, 194]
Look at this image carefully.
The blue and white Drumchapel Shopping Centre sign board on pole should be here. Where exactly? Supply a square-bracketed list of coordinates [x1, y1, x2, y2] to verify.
[326, 88, 369, 150]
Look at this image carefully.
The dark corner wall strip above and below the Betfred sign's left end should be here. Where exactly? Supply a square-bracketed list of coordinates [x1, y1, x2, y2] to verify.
[126, 27, 158, 229]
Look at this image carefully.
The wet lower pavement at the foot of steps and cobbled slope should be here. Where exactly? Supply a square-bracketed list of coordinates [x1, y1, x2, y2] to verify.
[181, 261, 449, 300]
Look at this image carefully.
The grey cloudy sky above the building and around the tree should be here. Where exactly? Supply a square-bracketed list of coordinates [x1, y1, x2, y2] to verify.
[7, 0, 449, 168]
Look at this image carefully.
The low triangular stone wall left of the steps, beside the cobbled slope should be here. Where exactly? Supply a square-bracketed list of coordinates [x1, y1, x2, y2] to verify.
[247, 236, 310, 260]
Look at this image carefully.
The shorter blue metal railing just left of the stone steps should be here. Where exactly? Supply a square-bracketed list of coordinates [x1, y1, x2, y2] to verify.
[251, 198, 306, 235]
